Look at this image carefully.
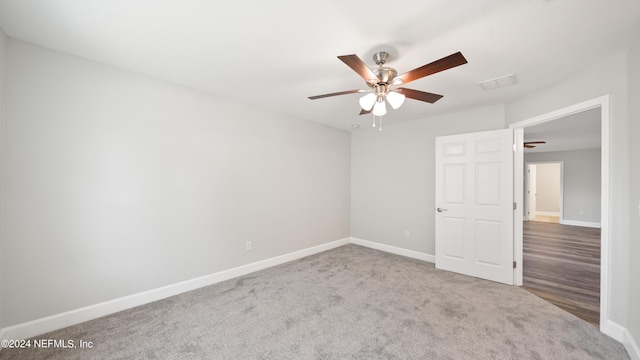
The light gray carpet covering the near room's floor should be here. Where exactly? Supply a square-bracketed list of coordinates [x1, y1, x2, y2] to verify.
[0, 245, 629, 360]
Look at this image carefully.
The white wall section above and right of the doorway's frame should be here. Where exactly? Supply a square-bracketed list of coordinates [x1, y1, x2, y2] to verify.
[505, 53, 630, 326]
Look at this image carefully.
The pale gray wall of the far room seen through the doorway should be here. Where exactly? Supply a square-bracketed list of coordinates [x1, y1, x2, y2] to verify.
[524, 149, 601, 223]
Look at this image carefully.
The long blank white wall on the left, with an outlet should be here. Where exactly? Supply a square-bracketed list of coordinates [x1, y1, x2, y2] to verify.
[0, 39, 350, 327]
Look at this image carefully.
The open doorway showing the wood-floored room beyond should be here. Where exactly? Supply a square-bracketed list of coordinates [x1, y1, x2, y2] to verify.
[522, 116, 601, 326]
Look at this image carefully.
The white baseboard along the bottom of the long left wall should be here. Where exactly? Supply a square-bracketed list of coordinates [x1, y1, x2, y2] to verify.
[0, 238, 351, 340]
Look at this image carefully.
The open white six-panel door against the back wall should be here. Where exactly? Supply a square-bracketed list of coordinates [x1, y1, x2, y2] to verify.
[435, 129, 514, 284]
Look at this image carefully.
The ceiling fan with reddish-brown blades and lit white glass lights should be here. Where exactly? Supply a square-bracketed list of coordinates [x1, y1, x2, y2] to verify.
[309, 51, 467, 118]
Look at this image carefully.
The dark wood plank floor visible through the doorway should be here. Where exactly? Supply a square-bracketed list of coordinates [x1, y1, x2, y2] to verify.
[522, 221, 600, 326]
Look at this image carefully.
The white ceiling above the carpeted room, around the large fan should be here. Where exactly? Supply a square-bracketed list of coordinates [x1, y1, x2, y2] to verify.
[0, 0, 640, 130]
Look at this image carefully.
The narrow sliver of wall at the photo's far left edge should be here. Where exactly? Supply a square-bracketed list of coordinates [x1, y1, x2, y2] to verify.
[0, 29, 8, 328]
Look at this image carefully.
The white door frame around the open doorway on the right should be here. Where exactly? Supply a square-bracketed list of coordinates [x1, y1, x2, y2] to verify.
[509, 95, 612, 334]
